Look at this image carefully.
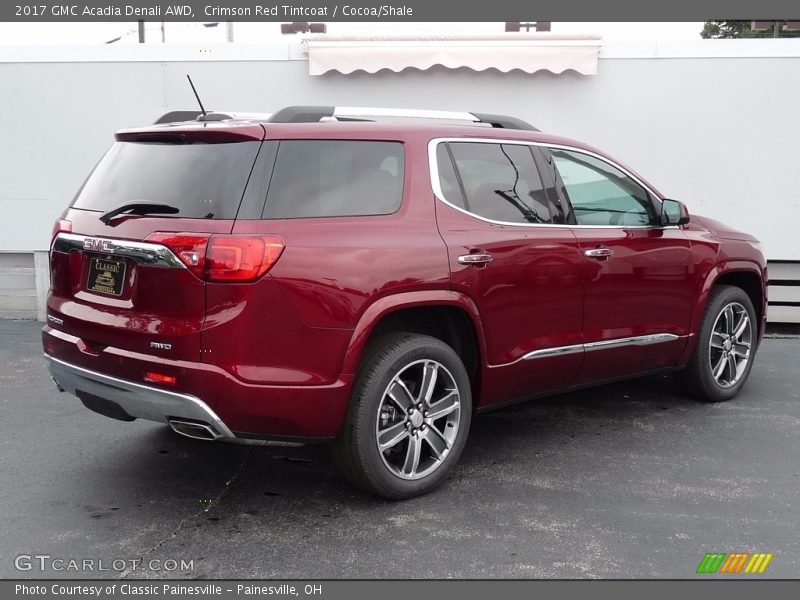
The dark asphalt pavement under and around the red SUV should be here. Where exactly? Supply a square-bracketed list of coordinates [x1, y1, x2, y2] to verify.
[0, 321, 800, 579]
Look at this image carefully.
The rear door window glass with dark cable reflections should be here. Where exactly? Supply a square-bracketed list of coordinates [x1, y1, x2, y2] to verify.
[440, 142, 554, 223]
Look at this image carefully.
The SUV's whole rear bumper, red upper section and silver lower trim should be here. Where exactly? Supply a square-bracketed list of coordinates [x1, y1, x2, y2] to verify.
[42, 326, 353, 443]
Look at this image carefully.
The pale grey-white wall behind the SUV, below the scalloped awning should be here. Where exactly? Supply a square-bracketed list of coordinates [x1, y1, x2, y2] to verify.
[0, 40, 800, 260]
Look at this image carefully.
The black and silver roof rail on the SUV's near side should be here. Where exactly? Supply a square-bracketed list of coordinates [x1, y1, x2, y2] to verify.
[269, 106, 539, 131]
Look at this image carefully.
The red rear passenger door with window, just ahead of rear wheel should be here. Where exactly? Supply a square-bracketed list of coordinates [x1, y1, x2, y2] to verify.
[431, 140, 583, 404]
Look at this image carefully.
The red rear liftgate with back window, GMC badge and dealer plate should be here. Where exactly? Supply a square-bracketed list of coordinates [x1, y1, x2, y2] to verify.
[48, 123, 264, 361]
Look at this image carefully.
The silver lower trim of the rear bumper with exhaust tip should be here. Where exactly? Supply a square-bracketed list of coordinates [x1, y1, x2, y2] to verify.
[45, 355, 236, 439]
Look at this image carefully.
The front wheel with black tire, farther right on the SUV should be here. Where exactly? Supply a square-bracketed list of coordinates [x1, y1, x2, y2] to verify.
[675, 285, 758, 402]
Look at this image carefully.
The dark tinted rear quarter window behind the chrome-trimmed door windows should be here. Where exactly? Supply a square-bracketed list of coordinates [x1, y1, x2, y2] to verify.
[262, 140, 404, 219]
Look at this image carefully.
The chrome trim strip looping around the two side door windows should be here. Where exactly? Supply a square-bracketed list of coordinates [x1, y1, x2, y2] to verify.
[428, 137, 678, 229]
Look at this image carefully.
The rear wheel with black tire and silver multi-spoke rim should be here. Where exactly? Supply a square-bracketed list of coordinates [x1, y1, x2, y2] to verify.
[333, 333, 472, 500]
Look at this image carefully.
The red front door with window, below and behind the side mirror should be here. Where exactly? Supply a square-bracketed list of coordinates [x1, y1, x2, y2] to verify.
[550, 148, 694, 382]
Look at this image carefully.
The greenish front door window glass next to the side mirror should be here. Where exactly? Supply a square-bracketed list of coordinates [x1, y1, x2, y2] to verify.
[550, 148, 655, 227]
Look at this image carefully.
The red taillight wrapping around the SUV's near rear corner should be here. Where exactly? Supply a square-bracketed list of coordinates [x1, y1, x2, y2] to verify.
[147, 232, 284, 283]
